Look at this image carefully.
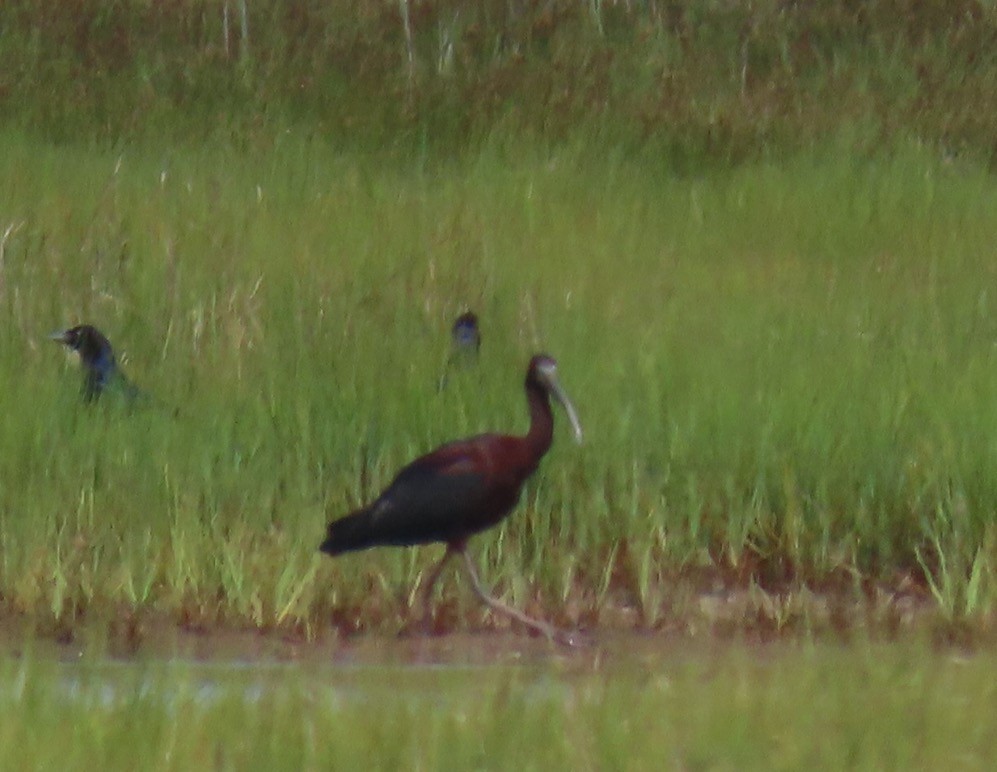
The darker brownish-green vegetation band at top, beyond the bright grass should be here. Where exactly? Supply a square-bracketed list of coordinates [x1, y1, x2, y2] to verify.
[0, 0, 997, 166]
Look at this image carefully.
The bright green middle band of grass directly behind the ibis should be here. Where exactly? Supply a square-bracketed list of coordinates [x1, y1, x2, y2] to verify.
[0, 132, 997, 632]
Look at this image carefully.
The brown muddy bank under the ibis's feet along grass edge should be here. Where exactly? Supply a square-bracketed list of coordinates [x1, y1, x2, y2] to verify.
[0, 586, 997, 665]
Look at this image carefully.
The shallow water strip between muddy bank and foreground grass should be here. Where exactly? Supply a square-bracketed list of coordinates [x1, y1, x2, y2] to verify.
[0, 634, 756, 707]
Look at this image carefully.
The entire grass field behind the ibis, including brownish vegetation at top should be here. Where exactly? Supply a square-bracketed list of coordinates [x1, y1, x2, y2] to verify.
[0, 0, 997, 635]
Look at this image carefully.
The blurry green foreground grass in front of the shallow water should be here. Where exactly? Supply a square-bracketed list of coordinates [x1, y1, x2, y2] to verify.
[0, 645, 997, 769]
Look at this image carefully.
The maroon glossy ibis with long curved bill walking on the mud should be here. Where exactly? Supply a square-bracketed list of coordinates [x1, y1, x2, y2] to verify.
[319, 354, 582, 643]
